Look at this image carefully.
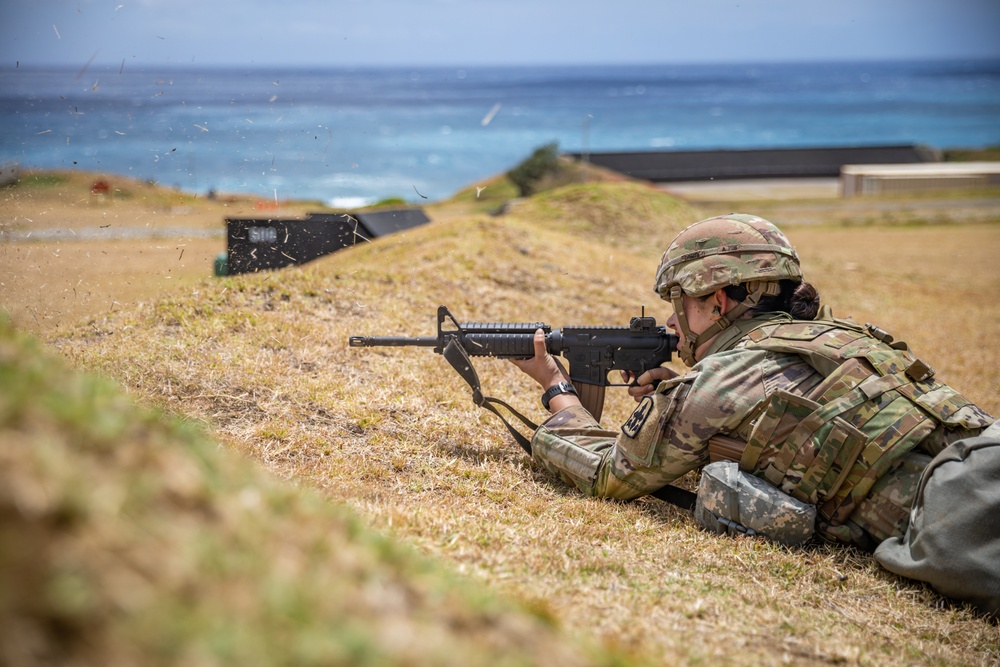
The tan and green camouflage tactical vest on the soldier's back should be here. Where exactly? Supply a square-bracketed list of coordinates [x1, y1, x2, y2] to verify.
[741, 320, 994, 541]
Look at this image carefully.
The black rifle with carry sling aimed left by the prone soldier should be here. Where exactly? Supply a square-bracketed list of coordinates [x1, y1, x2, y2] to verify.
[349, 306, 677, 455]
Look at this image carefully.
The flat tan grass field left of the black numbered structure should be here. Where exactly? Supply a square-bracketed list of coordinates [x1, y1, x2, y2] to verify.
[0, 171, 325, 333]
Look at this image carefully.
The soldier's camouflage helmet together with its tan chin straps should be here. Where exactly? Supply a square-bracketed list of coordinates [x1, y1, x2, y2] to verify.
[655, 213, 802, 366]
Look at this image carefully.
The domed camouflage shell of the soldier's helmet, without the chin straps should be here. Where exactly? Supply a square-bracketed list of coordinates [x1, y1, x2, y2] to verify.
[654, 213, 802, 299]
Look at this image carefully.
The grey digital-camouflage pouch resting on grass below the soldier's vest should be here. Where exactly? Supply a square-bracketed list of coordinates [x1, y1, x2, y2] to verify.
[694, 461, 816, 546]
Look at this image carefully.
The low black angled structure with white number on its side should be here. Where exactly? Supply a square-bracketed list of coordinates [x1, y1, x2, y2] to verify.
[223, 208, 430, 274]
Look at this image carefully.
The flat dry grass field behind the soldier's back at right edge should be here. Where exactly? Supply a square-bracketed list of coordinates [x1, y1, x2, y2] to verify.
[792, 225, 1000, 408]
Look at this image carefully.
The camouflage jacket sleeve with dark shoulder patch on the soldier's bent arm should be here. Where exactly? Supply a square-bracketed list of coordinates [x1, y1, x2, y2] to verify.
[532, 349, 815, 500]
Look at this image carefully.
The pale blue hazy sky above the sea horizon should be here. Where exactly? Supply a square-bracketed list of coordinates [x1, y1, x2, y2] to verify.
[0, 0, 1000, 68]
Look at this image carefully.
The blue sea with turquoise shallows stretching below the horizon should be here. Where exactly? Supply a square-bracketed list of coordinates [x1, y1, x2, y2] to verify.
[0, 60, 1000, 206]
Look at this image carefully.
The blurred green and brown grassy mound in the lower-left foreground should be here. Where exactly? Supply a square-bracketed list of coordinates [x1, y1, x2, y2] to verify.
[0, 318, 625, 667]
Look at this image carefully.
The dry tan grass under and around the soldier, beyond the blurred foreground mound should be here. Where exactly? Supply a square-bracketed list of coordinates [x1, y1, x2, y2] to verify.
[1, 174, 1000, 665]
